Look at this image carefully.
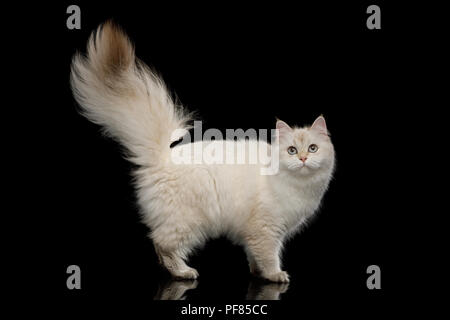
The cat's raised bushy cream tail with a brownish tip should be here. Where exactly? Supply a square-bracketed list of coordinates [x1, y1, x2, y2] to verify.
[71, 21, 190, 166]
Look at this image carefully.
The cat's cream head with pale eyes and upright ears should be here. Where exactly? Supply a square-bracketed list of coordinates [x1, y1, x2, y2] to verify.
[276, 116, 334, 176]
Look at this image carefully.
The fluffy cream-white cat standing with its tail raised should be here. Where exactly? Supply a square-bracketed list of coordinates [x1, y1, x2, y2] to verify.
[70, 21, 335, 282]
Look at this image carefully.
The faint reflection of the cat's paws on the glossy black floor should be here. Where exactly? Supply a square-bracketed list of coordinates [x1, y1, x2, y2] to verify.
[154, 279, 289, 300]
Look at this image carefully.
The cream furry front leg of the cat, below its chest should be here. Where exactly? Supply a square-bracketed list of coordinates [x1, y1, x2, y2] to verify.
[245, 230, 289, 282]
